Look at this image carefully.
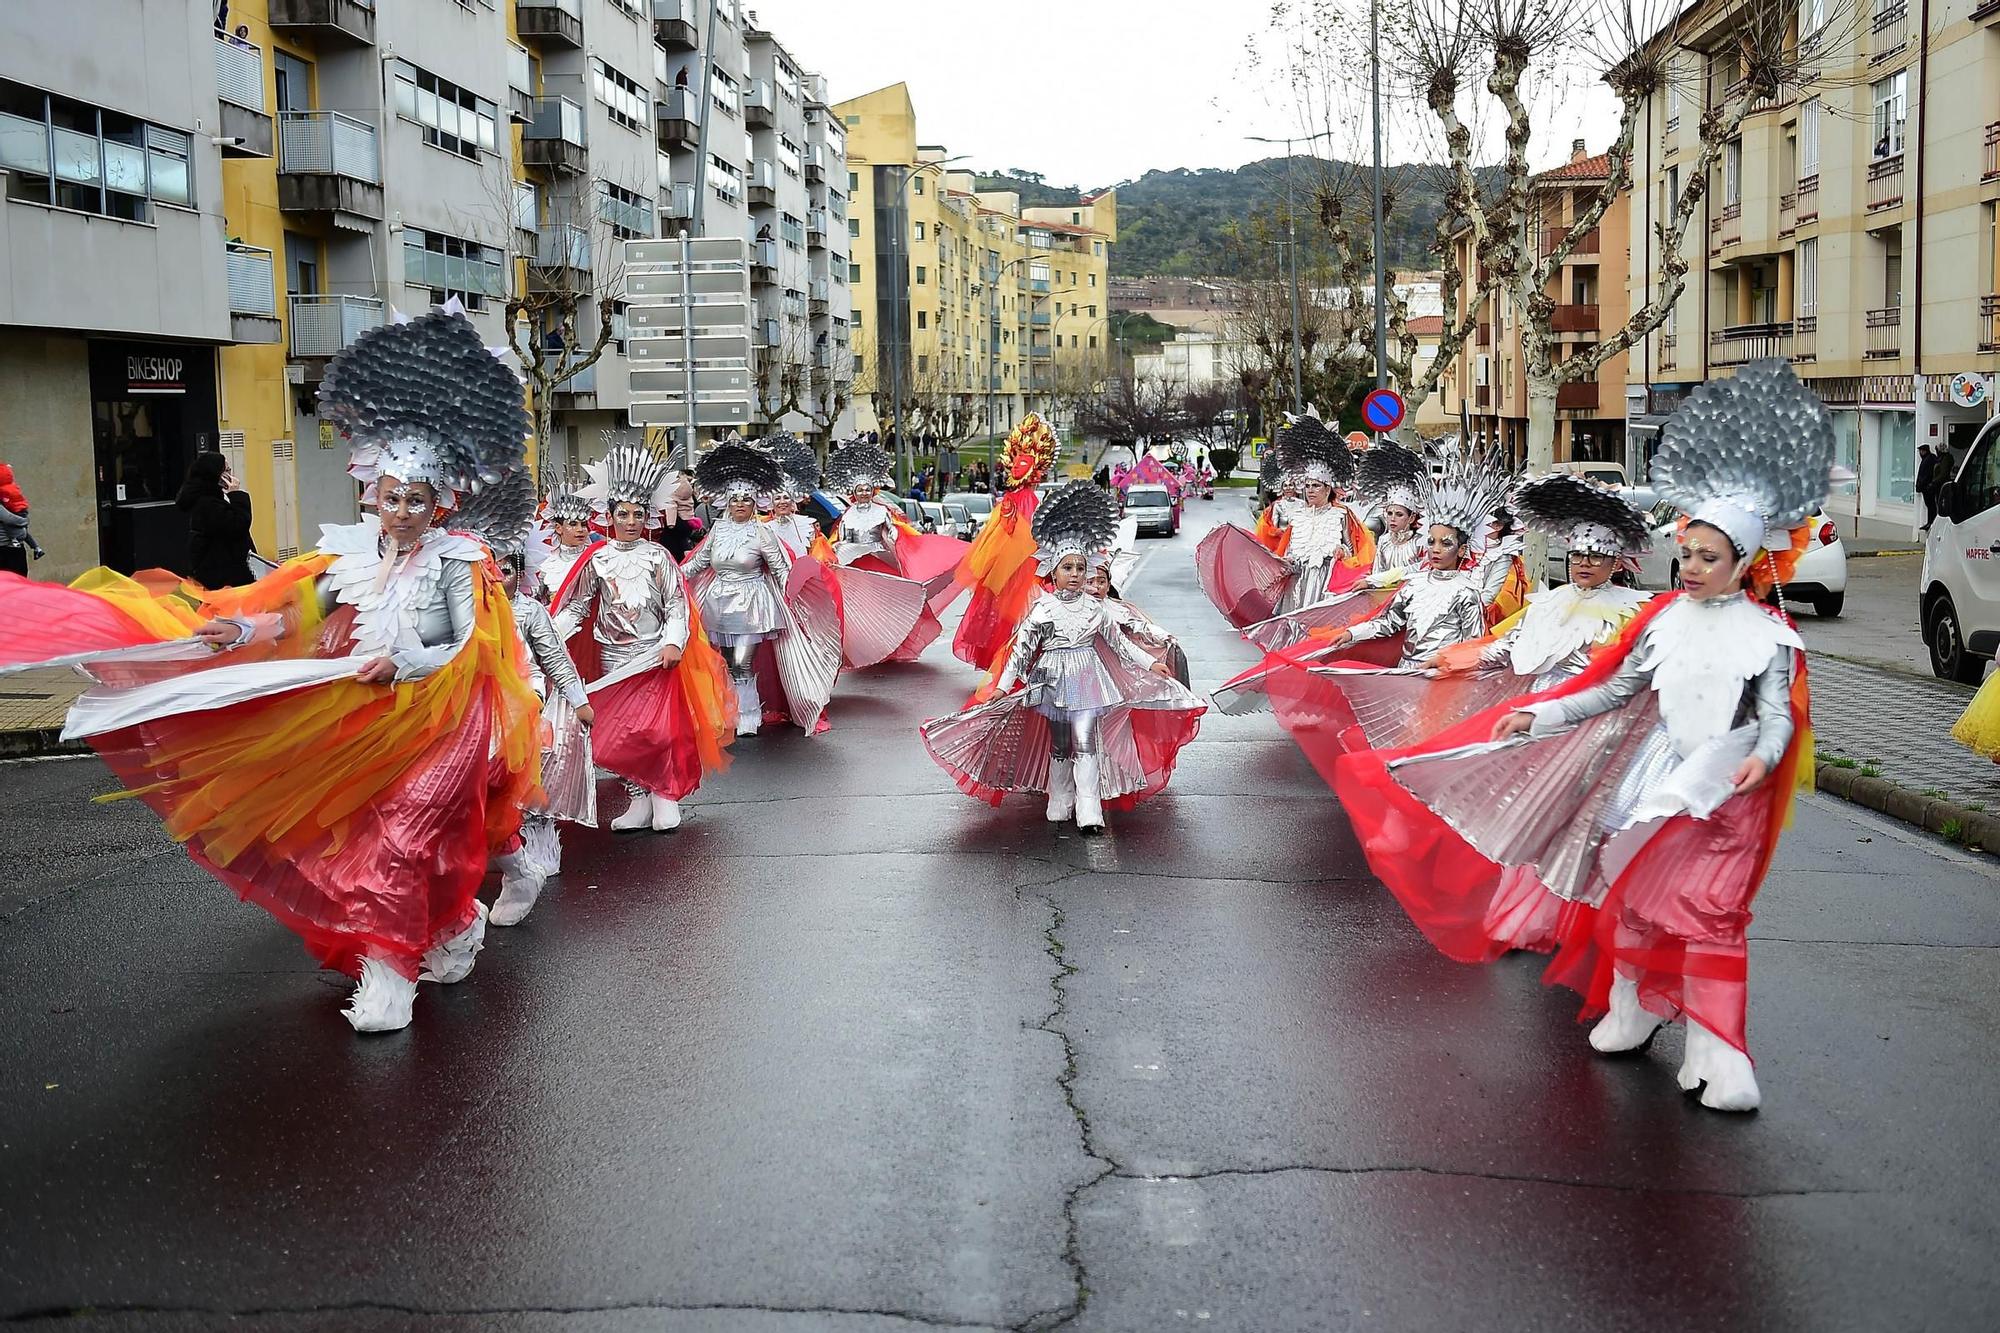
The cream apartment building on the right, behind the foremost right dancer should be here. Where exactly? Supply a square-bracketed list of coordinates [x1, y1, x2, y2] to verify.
[1630, 0, 2000, 536]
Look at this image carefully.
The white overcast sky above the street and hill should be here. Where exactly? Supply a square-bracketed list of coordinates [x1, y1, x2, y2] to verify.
[744, 0, 1616, 188]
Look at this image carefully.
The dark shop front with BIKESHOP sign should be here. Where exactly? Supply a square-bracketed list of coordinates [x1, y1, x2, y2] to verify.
[90, 338, 218, 574]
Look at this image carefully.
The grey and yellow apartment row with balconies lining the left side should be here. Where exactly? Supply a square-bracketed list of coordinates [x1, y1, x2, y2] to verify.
[0, 0, 846, 578]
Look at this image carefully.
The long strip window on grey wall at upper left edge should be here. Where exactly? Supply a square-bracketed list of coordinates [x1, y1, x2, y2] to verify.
[0, 80, 194, 222]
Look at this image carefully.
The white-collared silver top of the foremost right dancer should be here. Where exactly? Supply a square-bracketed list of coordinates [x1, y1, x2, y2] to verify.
[1524, 592, 1804, 769]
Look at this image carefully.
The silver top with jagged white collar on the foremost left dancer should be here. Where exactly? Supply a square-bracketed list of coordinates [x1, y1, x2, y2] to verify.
[316, 514, 486, 681]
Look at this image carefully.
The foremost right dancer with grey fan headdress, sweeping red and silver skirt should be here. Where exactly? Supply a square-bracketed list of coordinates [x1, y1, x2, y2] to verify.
[1336, 360, 1834, 1111]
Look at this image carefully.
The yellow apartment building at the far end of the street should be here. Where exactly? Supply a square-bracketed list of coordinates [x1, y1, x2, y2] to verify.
[832, 84, 1118, 446]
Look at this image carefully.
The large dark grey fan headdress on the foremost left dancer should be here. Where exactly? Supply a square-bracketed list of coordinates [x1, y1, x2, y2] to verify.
[320, 310, 528, 508]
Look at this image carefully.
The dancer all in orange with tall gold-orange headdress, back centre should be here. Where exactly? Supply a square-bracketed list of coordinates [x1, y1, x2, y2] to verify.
[952, 412, 1058, 671]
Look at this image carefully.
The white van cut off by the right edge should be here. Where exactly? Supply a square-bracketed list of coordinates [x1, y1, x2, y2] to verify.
[1918, 416, 2000, 685]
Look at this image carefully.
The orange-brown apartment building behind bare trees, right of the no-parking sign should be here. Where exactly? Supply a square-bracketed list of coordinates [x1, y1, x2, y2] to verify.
[1448, 140, 1632, 462]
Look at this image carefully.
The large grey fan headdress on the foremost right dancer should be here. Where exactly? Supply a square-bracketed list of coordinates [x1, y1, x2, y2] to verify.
[1652, 358, 1834, 558]
